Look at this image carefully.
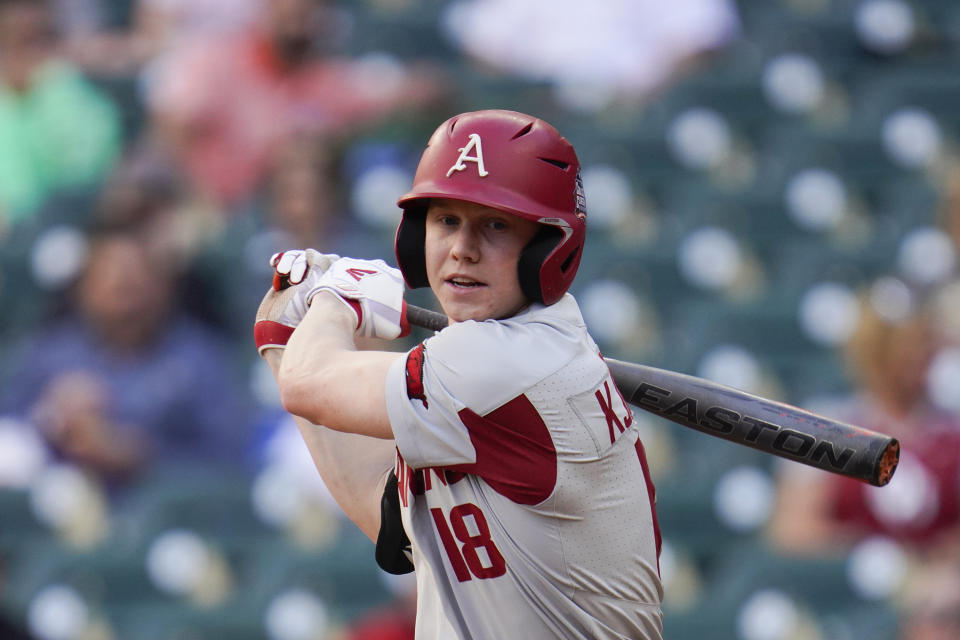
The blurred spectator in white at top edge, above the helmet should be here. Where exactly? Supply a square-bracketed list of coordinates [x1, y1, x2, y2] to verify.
[445, 0, 739, 107]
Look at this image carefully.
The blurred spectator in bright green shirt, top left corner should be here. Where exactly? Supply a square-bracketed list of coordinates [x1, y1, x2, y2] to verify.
[0, 0, 120, 226]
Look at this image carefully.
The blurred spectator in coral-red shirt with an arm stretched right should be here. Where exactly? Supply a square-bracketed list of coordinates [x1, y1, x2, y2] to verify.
[148, 0, 437, 205]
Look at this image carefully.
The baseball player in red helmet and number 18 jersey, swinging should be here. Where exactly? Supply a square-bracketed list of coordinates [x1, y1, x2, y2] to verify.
[255, 110, 662, 640]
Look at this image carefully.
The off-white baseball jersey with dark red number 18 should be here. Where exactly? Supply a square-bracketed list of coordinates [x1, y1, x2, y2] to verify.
[387, 294, 663, 640]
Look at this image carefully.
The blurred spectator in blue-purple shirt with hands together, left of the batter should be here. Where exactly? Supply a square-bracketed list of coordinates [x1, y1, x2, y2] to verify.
[0, 228, 250, 480]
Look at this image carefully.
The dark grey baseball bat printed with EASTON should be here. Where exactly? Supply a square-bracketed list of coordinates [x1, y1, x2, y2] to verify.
[406, 305, 900, 487]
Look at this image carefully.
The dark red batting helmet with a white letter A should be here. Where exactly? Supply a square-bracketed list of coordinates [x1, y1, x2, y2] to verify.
[396, 110, 587, 304]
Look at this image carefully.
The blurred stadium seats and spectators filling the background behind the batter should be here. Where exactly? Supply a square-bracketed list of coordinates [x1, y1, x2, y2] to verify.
[0, 0, 960, 640]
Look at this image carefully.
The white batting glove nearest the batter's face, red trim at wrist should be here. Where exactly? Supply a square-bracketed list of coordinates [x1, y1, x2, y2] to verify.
[316, 258, 410, 340]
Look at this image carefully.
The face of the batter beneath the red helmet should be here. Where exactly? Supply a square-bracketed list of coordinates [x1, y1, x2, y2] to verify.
[424, 199, 538, 322]
